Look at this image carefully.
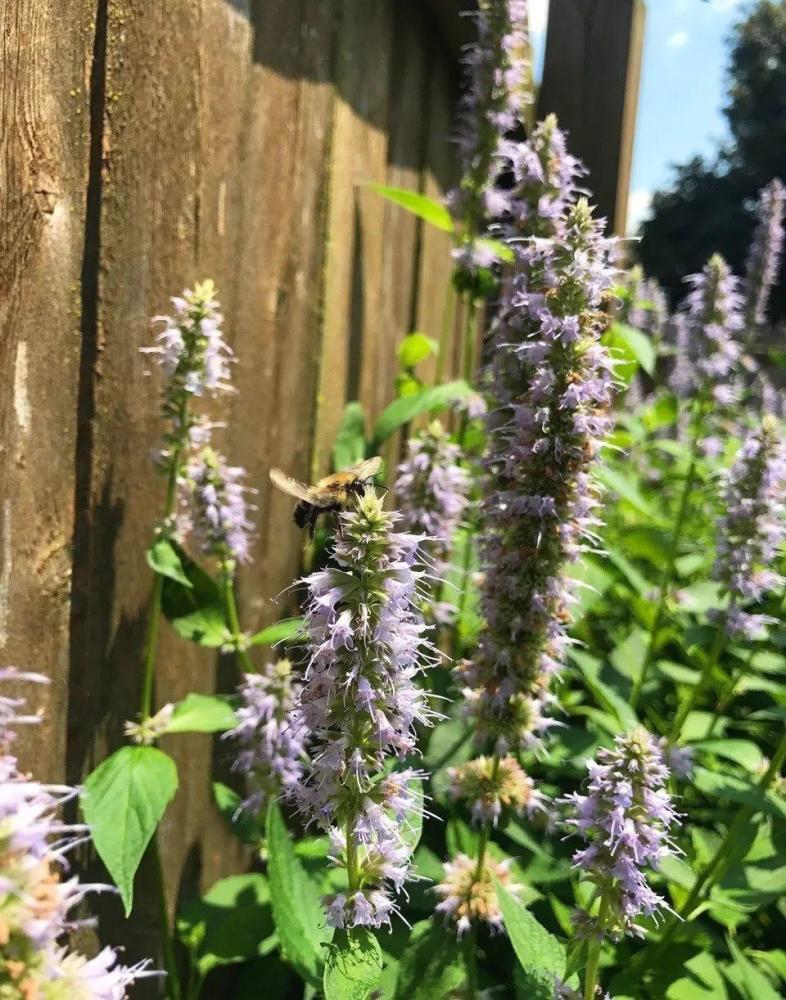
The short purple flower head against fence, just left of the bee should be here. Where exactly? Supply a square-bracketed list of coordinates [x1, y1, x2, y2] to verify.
[178, 448, 253, 563]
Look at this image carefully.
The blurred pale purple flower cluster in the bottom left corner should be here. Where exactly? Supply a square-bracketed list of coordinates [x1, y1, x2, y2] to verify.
[0, 667, 149, 1000]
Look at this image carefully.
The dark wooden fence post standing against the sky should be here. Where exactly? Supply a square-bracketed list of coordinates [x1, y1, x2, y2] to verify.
[538, 0, 645, 234]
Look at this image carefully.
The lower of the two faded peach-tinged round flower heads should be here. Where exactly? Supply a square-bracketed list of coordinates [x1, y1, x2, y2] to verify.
[434, 853, 523, 937]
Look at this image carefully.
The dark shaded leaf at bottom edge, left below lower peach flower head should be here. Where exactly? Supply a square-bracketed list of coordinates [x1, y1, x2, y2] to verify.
[395, 920, 464, 1000]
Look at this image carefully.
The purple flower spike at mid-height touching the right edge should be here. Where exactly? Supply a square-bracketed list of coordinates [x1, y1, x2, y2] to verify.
[713, 417, 786, 639]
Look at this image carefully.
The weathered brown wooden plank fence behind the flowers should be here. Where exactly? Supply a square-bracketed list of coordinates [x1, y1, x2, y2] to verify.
[0, 0, 628, 976]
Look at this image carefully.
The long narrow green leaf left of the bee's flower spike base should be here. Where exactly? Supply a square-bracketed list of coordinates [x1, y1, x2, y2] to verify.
[267, 803, 332, 989]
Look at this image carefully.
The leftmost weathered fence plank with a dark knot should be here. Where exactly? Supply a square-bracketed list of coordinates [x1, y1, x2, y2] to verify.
[0, 0, 92, 780]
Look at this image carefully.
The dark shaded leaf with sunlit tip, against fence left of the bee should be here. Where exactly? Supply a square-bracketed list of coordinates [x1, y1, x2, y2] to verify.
[161, 552, 228, 647]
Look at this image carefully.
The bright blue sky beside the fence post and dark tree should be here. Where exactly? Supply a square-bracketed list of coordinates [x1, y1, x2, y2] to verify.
[530, 0, 747, 232]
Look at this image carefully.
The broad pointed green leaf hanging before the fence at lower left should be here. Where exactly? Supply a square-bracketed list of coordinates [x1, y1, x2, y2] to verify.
[80, 747, 177, 916]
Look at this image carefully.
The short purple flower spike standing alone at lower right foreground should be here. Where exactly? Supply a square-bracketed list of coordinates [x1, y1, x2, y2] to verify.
[561, 729, 677, 939]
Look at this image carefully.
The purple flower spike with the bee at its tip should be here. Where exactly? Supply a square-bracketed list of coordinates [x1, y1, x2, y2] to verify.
[296, 490, 435, 928]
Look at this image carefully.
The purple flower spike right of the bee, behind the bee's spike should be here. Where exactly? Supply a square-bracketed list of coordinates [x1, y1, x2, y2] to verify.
[395, 420, 470, 573]
